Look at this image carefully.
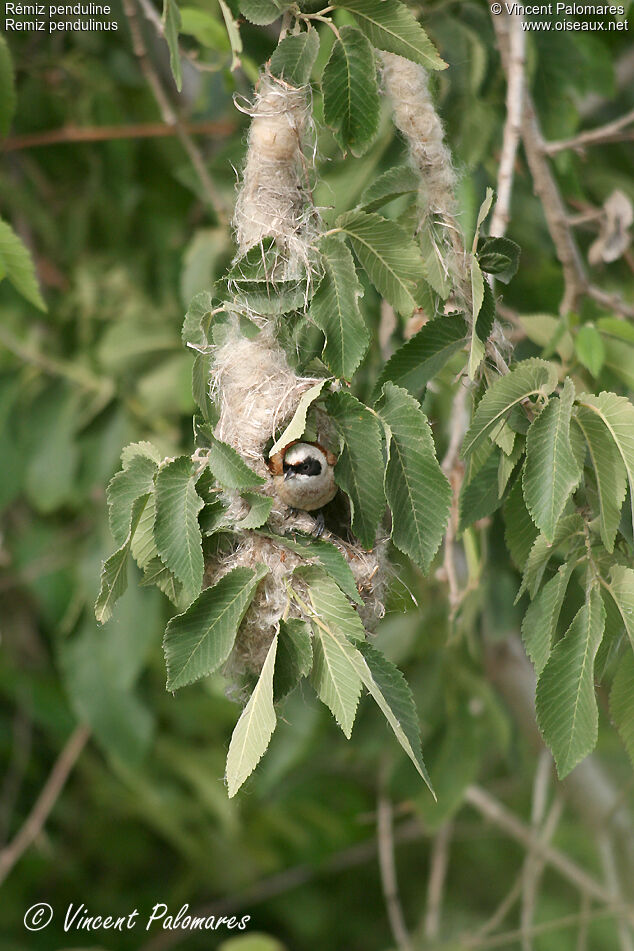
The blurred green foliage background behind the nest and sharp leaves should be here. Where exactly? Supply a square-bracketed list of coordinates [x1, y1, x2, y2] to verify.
[0, 0, 634, 951]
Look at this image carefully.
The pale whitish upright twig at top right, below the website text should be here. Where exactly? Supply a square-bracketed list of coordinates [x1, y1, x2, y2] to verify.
[490, 13, 526, 237]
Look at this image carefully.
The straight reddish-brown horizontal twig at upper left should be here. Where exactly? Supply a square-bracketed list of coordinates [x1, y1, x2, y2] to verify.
[2, 119, 236, 152]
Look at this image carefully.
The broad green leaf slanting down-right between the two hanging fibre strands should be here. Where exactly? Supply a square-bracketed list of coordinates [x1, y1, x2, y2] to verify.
[336, 211, 423, 316]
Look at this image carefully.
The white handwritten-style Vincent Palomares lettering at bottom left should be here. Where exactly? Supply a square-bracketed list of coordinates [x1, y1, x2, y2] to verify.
[64, 902, 251, 932]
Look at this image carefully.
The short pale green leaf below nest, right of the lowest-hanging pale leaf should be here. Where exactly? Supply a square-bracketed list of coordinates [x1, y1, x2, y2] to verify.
[311, 623, 361, 739]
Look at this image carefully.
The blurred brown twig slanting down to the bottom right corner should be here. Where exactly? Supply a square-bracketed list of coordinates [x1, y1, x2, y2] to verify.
[465, 786, 634, 920]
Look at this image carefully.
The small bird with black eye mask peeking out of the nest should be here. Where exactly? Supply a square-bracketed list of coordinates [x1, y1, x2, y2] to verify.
[268, 442, 337, 534]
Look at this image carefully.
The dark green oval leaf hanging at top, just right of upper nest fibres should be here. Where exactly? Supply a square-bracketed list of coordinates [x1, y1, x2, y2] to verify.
[321, 26, 379, 157]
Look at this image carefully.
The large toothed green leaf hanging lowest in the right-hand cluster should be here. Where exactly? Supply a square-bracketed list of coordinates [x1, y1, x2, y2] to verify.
[536, 587, 605, 779]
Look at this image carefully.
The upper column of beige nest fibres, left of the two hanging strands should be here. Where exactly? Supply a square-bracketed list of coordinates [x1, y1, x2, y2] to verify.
[233, 74, 318, 278]
